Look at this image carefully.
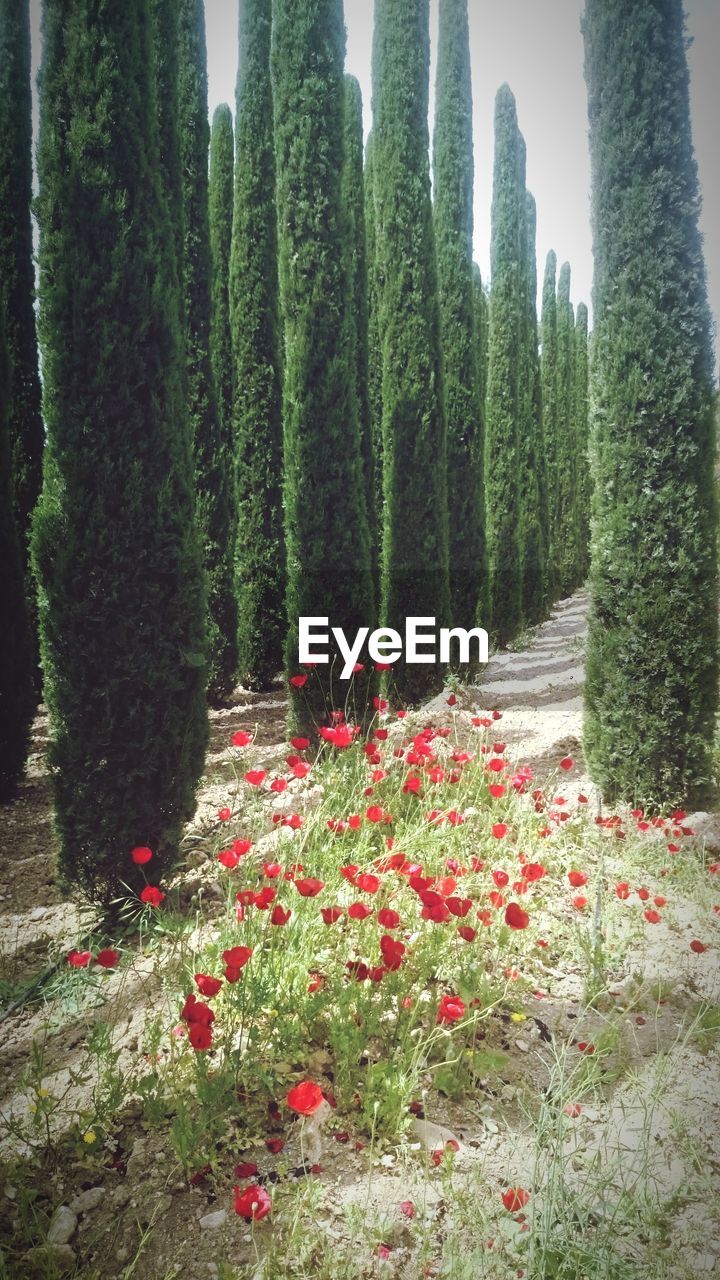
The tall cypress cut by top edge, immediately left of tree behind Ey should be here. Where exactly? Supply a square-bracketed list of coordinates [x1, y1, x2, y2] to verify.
[231, 0, 287, 689]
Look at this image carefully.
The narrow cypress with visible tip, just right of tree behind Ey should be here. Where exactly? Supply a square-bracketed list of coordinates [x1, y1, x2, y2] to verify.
[342, 76, 378, 591]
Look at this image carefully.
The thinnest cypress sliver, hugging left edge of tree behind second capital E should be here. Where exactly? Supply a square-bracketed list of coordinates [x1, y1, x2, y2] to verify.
[364, 133, 384, 581]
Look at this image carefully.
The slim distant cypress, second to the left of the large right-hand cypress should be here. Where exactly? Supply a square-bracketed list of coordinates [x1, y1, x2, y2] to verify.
[555, 262, 578, 596]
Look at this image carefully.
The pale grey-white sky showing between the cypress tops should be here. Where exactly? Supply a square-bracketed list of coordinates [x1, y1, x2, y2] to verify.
[25, 0, 720, 371]
